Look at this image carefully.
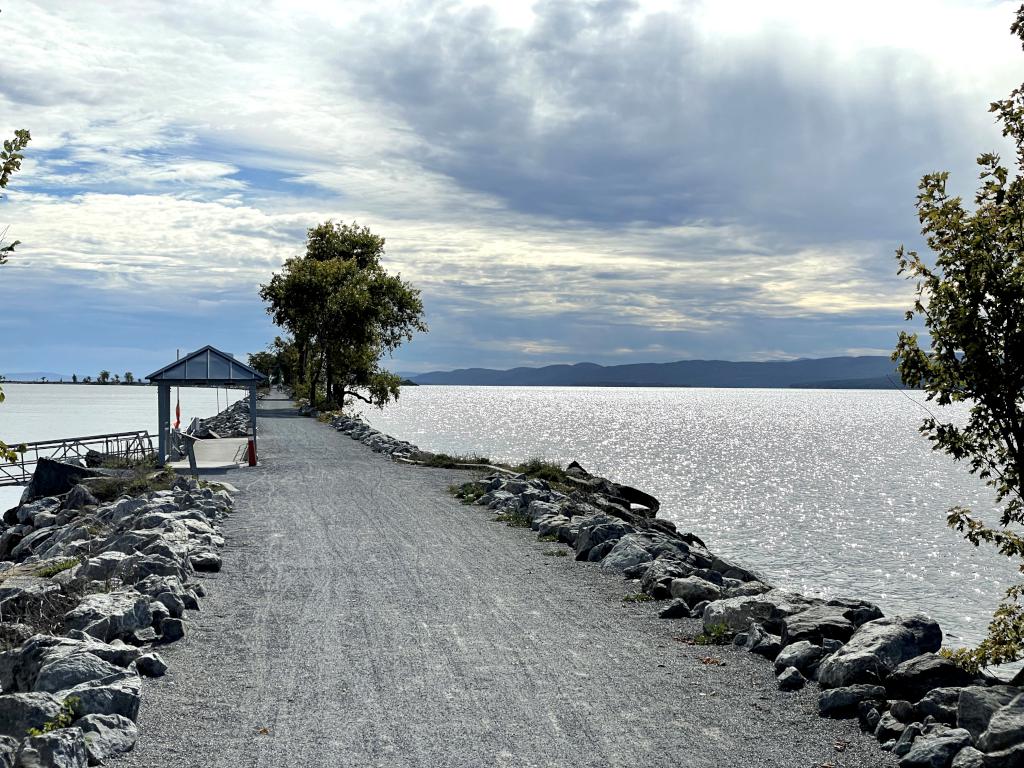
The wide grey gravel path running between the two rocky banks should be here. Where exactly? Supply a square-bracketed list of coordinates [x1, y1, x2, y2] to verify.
[116, 399, 894, 768]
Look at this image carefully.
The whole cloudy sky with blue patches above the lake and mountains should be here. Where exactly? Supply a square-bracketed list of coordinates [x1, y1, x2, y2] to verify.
[0, 0, 1024, 375]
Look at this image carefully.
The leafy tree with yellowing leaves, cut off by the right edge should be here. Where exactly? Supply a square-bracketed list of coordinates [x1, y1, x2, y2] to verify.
[893, 5, 1024, 667]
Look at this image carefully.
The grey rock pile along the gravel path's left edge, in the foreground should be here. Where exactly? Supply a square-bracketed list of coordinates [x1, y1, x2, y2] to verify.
[0, 466, 231, 768]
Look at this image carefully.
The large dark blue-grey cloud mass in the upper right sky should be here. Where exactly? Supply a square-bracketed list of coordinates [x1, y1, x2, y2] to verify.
[348, 1, 994, 240]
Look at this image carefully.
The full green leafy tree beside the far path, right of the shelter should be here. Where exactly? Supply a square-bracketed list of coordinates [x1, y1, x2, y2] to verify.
[260, 221, 427, 408]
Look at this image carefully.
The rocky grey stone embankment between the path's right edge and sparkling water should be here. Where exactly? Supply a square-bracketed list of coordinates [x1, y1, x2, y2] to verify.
[315, 415, 1024, 768]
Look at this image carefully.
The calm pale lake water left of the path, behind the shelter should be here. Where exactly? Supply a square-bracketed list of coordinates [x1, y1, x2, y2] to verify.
[0, 383, 234, 510]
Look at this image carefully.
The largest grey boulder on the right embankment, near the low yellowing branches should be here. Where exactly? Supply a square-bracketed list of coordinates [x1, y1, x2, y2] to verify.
[818, 614, 942, 688]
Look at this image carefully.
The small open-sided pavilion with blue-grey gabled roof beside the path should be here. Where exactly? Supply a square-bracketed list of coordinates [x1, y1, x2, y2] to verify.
[145, 345, 266, 466]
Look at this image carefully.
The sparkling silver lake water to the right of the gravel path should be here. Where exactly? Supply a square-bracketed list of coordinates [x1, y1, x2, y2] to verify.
[364, 386, 1019, 644]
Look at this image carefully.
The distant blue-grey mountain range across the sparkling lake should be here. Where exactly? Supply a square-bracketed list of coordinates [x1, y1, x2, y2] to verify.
[411, 355, 902, 389]
